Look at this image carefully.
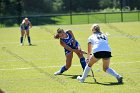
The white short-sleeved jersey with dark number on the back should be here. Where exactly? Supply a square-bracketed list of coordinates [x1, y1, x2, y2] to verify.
[88, 33, 111, 53]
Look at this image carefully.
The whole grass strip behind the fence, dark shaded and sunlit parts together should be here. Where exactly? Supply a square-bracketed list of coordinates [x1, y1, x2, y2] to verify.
[0, 12, 140, 27]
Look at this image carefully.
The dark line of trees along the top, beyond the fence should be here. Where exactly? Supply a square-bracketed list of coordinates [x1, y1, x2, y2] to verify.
[0, 0, 140, 16]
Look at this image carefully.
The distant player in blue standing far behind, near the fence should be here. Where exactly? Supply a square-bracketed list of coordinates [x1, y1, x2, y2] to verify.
[20, 18, 32, 45]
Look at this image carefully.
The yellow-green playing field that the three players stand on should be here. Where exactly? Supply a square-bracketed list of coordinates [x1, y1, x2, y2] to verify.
[0, 22, 140, 93]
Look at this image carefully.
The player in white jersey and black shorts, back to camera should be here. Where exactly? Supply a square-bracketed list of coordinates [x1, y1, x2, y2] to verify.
[77, 24, 123, 84]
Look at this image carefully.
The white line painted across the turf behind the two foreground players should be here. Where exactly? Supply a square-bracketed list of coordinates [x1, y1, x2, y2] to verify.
[0, 61, 140, 71]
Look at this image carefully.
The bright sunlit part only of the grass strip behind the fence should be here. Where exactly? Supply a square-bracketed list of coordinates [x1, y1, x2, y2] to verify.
[53, 12, 139, 24]
